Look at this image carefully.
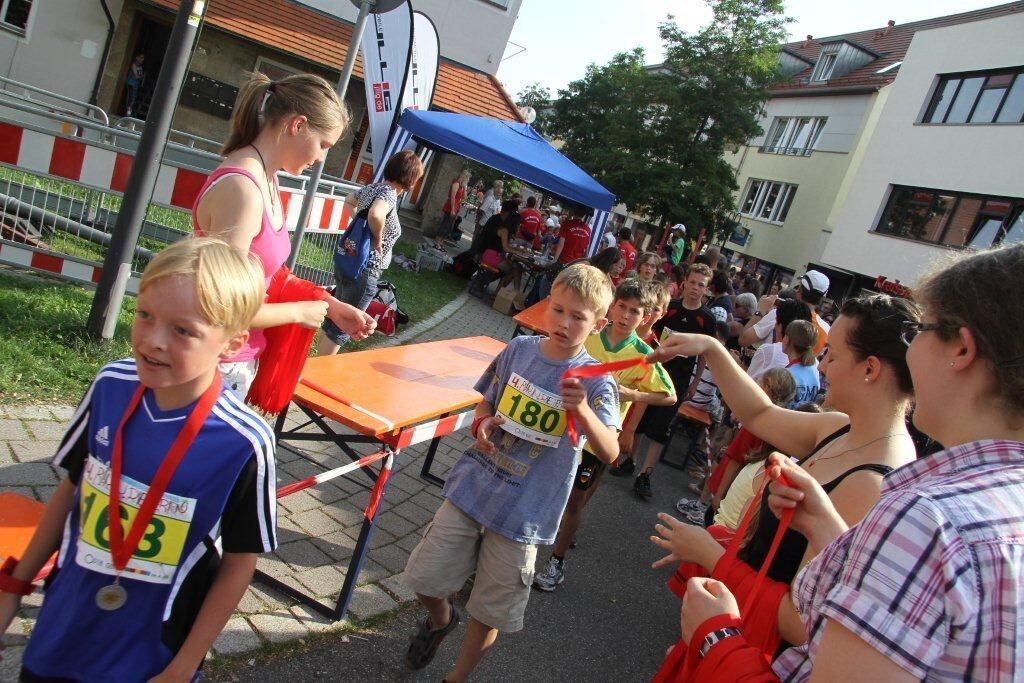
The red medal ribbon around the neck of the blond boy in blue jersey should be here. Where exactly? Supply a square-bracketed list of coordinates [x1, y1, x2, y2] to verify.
[108, 373, 223, 571]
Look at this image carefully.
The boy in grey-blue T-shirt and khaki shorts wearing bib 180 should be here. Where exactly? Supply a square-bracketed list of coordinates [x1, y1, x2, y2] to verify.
[404, 264, 618, 681]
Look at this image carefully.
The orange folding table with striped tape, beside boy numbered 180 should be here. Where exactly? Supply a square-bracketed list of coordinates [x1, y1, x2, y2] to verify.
[257, 337, 505, 620]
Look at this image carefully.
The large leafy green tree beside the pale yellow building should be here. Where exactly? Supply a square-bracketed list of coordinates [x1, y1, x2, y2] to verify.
[550, 0, 787, 238]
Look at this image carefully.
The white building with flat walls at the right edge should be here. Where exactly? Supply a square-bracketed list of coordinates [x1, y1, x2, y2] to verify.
[822, 11, 1024, 294]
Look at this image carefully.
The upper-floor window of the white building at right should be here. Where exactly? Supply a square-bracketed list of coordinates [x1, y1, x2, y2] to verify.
[924, 67, 1024, 123]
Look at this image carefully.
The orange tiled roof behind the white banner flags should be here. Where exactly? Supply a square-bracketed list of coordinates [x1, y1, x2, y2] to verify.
[148, 0, 522, 121]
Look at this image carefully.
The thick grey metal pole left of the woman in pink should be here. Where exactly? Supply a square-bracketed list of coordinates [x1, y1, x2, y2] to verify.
[86, 0, 206, 341]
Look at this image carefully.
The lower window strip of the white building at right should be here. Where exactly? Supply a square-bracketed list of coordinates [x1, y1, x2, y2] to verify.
[874, 186, 1024, 249]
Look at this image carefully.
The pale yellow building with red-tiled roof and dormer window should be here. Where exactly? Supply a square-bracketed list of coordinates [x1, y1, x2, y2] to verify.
[726, 2, 1024, 292]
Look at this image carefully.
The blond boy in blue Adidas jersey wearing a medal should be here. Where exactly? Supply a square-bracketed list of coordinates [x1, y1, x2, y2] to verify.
[0, 239, 276, 681]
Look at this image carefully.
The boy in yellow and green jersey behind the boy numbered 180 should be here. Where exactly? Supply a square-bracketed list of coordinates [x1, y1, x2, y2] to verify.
[534, 280, 676, 592]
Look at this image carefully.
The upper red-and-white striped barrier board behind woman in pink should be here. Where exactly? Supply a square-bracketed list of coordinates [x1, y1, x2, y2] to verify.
[0, 122, 351, 237]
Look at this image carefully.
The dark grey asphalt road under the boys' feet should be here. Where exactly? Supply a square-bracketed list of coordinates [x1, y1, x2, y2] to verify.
[210, 448, 690, 682]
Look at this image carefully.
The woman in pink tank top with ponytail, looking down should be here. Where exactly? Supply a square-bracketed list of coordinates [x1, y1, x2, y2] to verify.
[193, 74, 374, 398]
